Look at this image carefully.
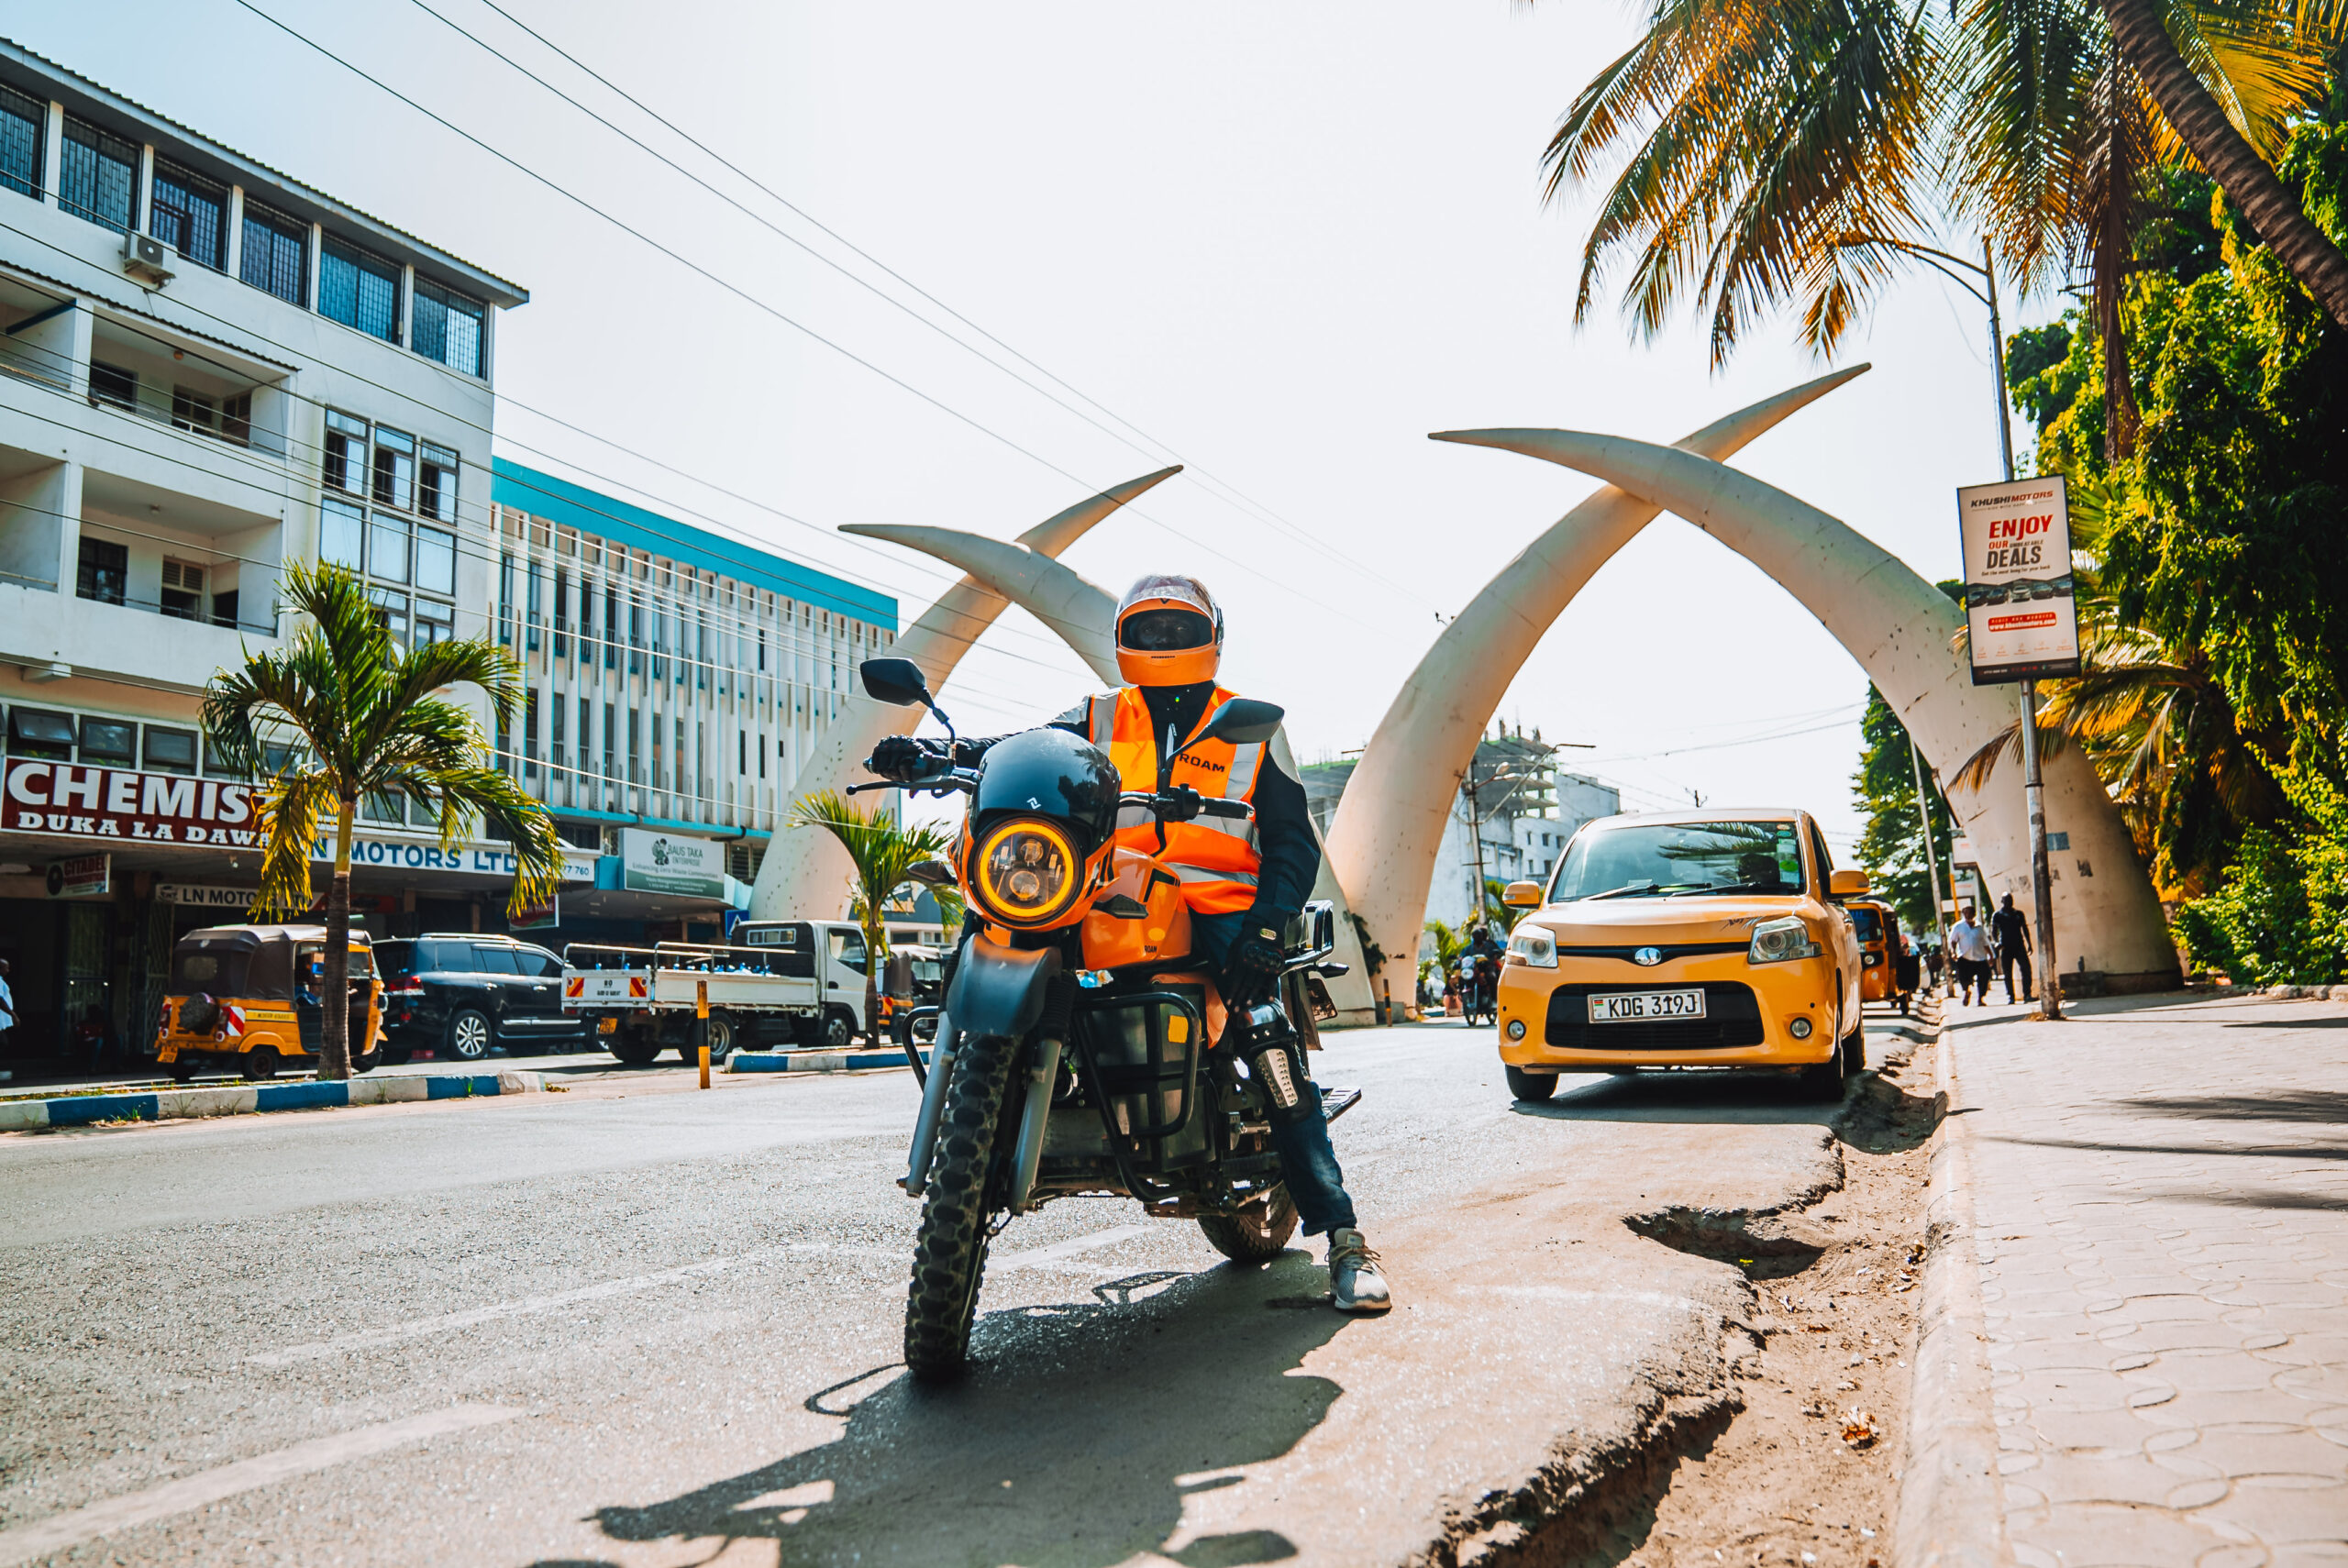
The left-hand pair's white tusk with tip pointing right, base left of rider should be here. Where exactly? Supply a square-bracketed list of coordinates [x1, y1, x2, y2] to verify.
[749, 462, 1181, 920]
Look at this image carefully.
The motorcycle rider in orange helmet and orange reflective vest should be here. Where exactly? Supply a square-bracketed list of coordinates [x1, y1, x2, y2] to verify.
[867, 575, 1392, 1312]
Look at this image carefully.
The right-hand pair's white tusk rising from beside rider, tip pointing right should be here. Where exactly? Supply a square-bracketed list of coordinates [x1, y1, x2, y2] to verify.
[1329, 364, 1866, 1011]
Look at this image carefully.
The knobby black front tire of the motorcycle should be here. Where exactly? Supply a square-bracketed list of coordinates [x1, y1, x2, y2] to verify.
[904, 1035, 1016, 1383]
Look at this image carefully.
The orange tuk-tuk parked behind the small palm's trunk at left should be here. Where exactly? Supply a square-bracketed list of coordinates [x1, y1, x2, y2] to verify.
[155, 925, 382, 1082]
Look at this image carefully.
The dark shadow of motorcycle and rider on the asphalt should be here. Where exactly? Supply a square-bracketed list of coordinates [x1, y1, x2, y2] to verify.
[556, 1251, 1350, 1568]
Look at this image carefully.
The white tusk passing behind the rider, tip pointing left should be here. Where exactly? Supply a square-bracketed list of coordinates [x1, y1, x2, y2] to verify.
[847, 524, 1376, 1023]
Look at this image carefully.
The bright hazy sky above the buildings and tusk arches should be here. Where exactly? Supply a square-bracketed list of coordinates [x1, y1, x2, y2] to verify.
[28, 0, 2052, 838]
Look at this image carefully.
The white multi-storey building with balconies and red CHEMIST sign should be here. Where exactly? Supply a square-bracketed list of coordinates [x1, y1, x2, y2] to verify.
[0, 42, 518, 1049]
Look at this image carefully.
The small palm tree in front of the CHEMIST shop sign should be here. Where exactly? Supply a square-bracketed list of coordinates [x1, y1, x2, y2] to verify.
[202, 561, 563, 1077]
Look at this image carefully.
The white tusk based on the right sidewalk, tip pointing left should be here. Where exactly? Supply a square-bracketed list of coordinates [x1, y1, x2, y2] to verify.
[1434, 429, 2176, 990]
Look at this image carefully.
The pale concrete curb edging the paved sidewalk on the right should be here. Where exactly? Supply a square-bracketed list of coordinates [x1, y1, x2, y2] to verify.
[1892, 1021, 2014, 1568]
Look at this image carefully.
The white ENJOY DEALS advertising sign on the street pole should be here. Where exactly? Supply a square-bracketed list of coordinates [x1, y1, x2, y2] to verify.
[1955, 474, 2078, 685]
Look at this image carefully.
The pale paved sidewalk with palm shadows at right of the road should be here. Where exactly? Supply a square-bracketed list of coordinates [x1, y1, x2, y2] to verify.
[1946, 995, 2348, 1568]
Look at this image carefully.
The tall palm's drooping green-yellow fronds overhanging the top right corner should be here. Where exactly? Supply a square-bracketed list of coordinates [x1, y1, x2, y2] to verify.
[1545, 0, 2348, 380]
